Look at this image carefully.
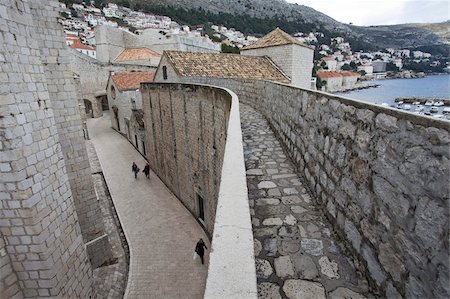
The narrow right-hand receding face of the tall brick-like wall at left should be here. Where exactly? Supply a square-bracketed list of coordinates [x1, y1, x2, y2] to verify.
[30, 0, 108, 252]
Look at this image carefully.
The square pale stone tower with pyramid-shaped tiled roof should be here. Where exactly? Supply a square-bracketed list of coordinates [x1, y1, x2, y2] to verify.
[241, 28, 314, 89]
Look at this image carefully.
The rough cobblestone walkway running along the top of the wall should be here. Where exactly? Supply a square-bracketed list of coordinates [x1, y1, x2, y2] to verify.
[240, 104, 367, 299]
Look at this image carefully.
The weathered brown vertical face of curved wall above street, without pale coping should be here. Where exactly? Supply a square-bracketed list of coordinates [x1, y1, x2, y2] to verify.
[141, 84, 231, 236]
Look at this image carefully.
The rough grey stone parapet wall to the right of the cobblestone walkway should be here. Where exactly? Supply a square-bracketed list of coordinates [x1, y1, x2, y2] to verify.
[178, 78, 450, 298]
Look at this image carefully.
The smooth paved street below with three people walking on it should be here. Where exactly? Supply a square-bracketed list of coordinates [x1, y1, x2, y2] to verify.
[88, 113, 210, 299]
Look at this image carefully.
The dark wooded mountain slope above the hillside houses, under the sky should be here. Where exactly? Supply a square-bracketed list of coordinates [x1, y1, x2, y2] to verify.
[106, 0, 450, 55]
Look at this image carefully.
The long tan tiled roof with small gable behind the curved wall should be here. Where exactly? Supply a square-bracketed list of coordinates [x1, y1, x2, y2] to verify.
[155, 51, 290, 84]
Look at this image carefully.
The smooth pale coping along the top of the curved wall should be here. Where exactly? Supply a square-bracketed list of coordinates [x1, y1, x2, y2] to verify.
[141, 82, 257, 299]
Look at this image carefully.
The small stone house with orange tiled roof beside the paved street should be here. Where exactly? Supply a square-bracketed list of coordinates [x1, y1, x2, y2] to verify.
[106, 72, 155, 156]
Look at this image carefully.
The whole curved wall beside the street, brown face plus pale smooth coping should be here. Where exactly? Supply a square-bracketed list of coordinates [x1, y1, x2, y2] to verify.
[141, 83, 257, 299]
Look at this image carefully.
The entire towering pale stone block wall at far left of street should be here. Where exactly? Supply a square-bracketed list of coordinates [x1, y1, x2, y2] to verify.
[0, 0, 111, 298]
